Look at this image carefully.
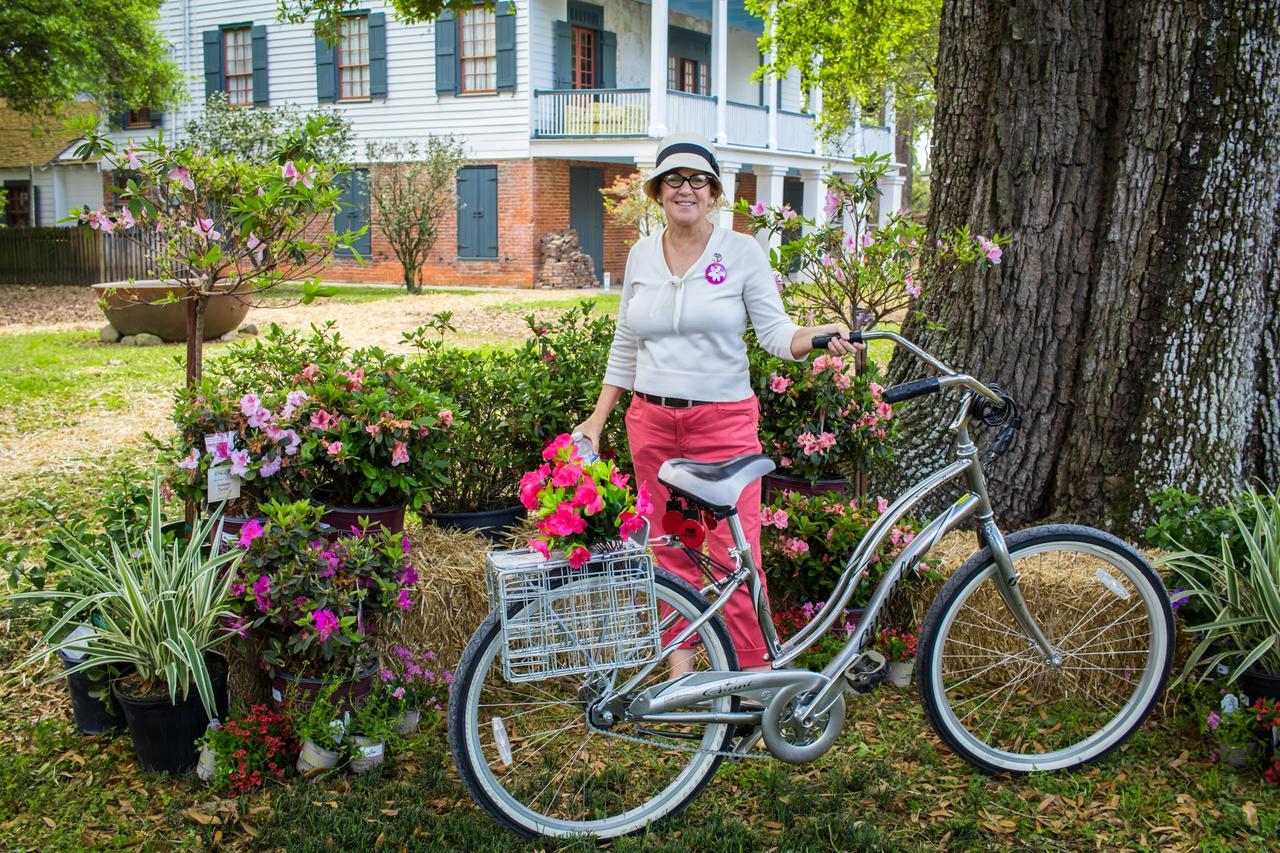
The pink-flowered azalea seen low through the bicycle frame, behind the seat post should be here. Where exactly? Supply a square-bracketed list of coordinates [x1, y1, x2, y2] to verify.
[760, 492, 928, 607]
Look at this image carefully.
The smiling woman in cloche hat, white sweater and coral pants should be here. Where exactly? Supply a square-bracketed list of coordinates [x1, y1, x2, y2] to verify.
[577, 134, 854, 674]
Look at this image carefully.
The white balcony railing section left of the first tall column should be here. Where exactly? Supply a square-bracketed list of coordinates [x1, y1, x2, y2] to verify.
[532, 88, 650, 137]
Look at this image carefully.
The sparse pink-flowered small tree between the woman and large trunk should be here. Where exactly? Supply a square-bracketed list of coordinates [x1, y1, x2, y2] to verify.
[737, 155, 1006, 338]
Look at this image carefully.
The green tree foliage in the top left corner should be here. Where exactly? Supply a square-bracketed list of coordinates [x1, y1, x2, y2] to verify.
[0, 0, 182, 115]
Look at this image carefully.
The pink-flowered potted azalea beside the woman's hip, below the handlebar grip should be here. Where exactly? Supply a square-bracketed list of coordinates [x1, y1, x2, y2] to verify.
[749, 347, 897, 483]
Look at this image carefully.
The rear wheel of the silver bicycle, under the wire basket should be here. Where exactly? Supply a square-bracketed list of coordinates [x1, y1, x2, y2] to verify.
[449, 569, 737, 838]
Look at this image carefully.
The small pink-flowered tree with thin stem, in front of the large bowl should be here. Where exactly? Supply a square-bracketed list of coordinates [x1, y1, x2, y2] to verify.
[69, 117, 360, 388]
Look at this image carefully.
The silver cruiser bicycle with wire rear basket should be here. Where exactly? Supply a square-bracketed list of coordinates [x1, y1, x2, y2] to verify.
[448, 332, 1174, 838]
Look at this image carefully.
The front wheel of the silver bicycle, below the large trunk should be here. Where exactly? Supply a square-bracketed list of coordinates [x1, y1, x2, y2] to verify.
[919, 525, 1174, 774]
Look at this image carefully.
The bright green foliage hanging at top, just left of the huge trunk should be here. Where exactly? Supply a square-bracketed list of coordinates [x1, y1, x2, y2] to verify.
[746, 0, 942, 136]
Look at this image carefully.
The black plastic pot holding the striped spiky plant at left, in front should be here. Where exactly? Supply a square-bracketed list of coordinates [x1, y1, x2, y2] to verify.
[111, 658, 227, 774]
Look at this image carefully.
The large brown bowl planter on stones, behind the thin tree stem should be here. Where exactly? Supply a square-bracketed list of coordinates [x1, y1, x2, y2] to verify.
[93, 278, 248, 343]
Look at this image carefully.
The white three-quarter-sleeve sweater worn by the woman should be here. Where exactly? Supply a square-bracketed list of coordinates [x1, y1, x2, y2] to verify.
[604, 225, 799, 402]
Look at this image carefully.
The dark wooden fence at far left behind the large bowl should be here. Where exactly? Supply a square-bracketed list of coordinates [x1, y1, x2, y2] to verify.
[0, 225, 157, 284]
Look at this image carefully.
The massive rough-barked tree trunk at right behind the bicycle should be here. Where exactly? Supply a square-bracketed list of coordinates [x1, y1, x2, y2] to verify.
[887, 0, 1280, 529]
